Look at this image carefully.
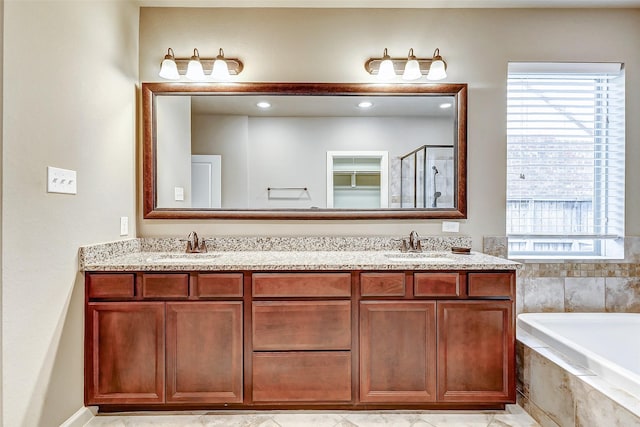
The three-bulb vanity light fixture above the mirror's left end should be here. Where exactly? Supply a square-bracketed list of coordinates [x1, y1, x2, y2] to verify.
[159, 48, 244, 81]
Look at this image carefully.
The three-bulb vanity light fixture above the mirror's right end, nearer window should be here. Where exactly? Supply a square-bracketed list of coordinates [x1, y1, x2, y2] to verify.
[364, 48, 447, 80]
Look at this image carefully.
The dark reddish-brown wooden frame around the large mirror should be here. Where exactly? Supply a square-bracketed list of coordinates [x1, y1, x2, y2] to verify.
[142, 83, 467, 220]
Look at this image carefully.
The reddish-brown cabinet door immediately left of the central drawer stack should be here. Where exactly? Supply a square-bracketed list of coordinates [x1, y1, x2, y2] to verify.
[167, 301, 242, 403]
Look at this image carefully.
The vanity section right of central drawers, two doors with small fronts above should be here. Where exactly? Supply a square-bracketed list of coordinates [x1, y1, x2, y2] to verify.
[359, 272, 515, 405]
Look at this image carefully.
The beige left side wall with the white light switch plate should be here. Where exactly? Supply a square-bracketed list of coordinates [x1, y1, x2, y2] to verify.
[2, 0, 138, 427]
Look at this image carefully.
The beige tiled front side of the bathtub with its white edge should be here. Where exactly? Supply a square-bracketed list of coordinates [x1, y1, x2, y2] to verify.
[516, 328, 640, 427]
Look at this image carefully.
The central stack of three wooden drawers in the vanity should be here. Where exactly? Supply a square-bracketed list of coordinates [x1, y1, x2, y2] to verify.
[251, 272, 353, 405]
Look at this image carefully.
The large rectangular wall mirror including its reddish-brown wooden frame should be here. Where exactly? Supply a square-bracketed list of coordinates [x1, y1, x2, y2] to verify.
[142, 83, 467, 219]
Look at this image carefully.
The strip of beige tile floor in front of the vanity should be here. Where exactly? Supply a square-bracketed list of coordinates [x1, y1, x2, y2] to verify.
[85, 405, 539, 427]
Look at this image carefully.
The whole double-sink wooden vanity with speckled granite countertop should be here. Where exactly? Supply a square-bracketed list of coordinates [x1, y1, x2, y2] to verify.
[83, 244, 517, 411]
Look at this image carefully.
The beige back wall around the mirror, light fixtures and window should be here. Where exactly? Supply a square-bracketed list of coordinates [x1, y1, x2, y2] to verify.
[139, 8, 640, 244]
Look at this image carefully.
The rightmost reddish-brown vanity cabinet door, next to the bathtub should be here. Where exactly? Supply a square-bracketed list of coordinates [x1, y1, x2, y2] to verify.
[438, 301, 515, 403]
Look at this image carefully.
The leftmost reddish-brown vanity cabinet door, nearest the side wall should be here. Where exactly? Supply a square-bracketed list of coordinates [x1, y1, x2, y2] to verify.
[85, 302, 165, 405]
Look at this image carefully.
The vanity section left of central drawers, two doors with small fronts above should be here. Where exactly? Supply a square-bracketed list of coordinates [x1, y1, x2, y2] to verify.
[85, 273, 243, 408]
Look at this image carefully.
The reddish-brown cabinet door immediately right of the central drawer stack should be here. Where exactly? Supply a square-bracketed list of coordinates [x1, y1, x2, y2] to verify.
[360, 301, 436, 403]
